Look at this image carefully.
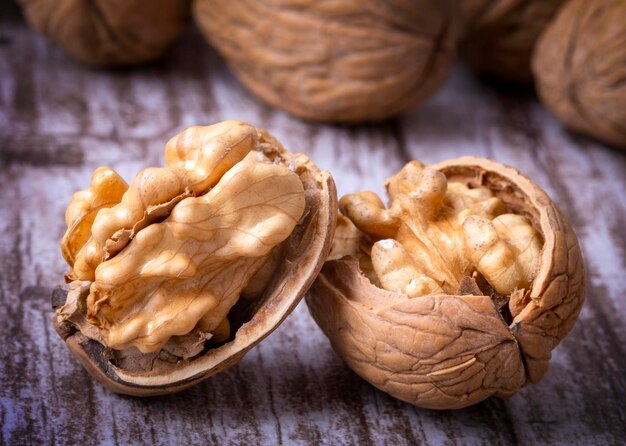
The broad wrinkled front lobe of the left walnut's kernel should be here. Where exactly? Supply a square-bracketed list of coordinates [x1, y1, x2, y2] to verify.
[87, 153, 304, 353]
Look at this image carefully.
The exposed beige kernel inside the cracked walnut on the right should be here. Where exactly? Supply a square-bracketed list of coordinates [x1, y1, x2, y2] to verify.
[340, 161, 520, 294]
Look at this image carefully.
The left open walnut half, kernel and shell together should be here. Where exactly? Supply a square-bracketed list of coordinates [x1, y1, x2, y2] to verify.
[53, 121, 337, 396]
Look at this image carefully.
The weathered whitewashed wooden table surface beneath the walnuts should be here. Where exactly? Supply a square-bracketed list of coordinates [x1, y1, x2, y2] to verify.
[0, 2, 626, 445]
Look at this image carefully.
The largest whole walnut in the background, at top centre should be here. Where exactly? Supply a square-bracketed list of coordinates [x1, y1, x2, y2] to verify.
[193, 0, 458, 123]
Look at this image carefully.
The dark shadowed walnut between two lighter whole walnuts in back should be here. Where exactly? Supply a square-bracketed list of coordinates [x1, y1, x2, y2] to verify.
[459, 0, 564, 84]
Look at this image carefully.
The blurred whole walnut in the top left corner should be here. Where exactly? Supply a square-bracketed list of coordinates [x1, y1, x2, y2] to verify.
[18, 0, 191, 67]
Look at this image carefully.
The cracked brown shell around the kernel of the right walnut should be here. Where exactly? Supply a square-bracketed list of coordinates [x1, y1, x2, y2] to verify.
[306, 157, 584, 409]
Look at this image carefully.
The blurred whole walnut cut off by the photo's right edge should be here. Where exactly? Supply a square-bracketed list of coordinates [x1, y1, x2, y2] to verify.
[533, 0, 626, 148]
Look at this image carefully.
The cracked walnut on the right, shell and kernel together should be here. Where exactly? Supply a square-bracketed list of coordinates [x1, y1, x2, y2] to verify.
[307, 157, 584, 409]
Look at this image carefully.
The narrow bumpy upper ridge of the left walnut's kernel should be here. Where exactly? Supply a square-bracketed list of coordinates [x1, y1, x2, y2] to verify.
[68, 121, 258, 281]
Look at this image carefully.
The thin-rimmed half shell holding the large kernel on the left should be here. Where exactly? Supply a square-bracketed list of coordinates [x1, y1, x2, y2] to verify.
[52, 123, 337, 396]
